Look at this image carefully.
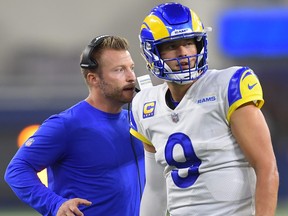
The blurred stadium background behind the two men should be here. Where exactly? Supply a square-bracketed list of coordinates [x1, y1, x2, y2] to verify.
[0, 0, 288, 216]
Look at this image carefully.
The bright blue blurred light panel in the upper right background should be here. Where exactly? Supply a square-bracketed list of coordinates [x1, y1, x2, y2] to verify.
[218, 8, 288, 58]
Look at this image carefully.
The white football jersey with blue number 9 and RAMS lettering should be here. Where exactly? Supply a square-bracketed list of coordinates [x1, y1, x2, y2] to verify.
[131, 67, 264, 216]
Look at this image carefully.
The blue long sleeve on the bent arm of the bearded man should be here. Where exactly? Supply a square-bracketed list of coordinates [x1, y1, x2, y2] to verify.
[5, 116, 67, 215]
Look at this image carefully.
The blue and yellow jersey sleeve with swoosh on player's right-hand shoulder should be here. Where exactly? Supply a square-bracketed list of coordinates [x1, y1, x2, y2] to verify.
[227, 67, 264, 122]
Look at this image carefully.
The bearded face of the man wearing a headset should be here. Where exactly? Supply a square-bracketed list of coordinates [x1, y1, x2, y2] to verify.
[99, 50, 136, 104]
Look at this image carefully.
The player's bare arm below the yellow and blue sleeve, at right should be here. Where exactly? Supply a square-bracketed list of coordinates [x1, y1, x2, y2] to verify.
[230, 102, 279, 216]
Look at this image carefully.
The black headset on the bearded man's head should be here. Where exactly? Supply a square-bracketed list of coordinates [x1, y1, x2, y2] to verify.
[80, 35, 110, 69]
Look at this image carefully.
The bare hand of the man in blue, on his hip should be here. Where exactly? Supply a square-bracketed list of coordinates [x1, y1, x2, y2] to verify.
[57, 198, 92, 216]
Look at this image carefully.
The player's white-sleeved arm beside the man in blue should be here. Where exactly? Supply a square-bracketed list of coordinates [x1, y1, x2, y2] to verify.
[140, 144, 167, 216]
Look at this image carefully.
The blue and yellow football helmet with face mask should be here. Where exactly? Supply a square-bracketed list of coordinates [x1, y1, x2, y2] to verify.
[139, 3, 208, 84]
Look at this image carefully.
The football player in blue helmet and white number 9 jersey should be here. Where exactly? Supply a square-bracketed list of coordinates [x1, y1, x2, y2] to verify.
[130, 3, 279, 216]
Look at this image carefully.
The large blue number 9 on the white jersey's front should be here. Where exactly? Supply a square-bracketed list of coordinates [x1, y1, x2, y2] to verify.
[165, 133, 201, 188]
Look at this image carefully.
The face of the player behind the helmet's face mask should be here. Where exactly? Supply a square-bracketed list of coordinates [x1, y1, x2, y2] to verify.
[158, 38, 197, 71]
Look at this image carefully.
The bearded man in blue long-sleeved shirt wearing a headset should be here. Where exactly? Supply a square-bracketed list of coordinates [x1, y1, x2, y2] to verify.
[5, 35, 144, 216]
